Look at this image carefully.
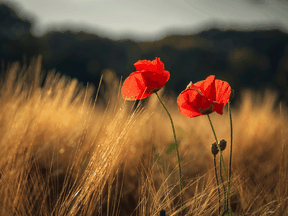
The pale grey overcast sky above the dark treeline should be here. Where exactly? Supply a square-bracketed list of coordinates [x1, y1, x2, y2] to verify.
[0, 0, 288, 41]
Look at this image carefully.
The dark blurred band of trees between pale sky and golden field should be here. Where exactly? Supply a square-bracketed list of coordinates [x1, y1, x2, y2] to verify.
[0, 4, 288, 107]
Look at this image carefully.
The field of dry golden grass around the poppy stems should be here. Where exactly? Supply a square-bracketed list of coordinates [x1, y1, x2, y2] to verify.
[0, 56, 288, 216]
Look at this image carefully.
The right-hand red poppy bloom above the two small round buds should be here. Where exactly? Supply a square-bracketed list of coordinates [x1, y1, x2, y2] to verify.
[177, 75, 231, 118]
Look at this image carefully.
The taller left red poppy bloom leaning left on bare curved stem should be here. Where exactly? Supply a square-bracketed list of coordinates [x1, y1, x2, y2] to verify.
[122, 58, 170, 100]
